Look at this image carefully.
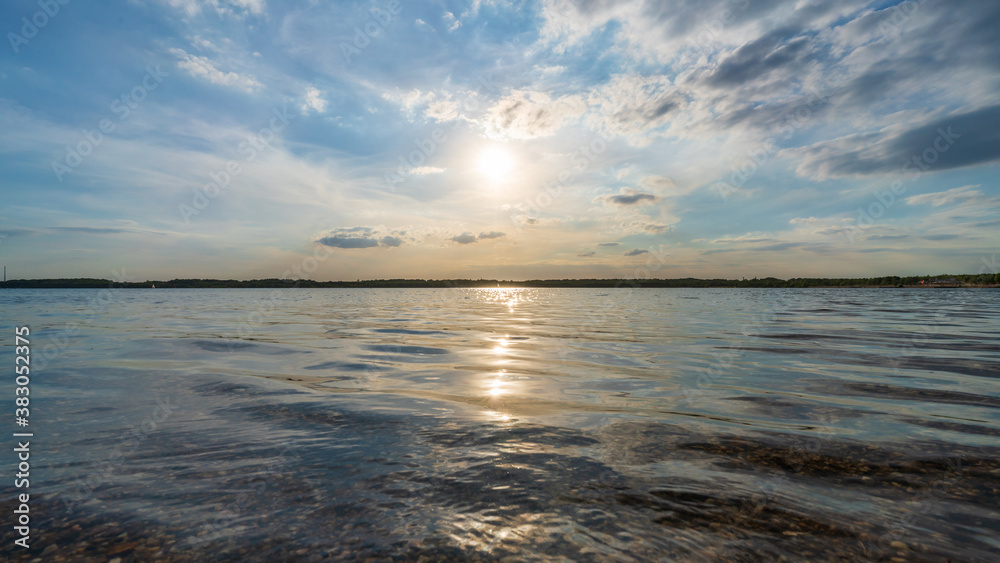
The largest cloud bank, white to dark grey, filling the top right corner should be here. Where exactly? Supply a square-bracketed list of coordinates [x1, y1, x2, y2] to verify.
[540, 0, 1000, 152]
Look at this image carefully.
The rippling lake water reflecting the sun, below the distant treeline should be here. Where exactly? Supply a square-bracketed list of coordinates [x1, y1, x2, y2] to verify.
[0, 289, 1000, 561]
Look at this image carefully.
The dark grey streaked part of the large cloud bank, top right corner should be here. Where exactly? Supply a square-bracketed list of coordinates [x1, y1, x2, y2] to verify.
[670, 2, 1000, 139]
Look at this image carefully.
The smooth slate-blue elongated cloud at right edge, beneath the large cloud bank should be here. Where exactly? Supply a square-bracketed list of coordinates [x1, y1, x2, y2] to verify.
[790, 105, 1000, 180]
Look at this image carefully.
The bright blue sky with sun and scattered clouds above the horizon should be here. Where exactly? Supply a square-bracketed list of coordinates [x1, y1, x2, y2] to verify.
[0, 0, 1000, 281]
